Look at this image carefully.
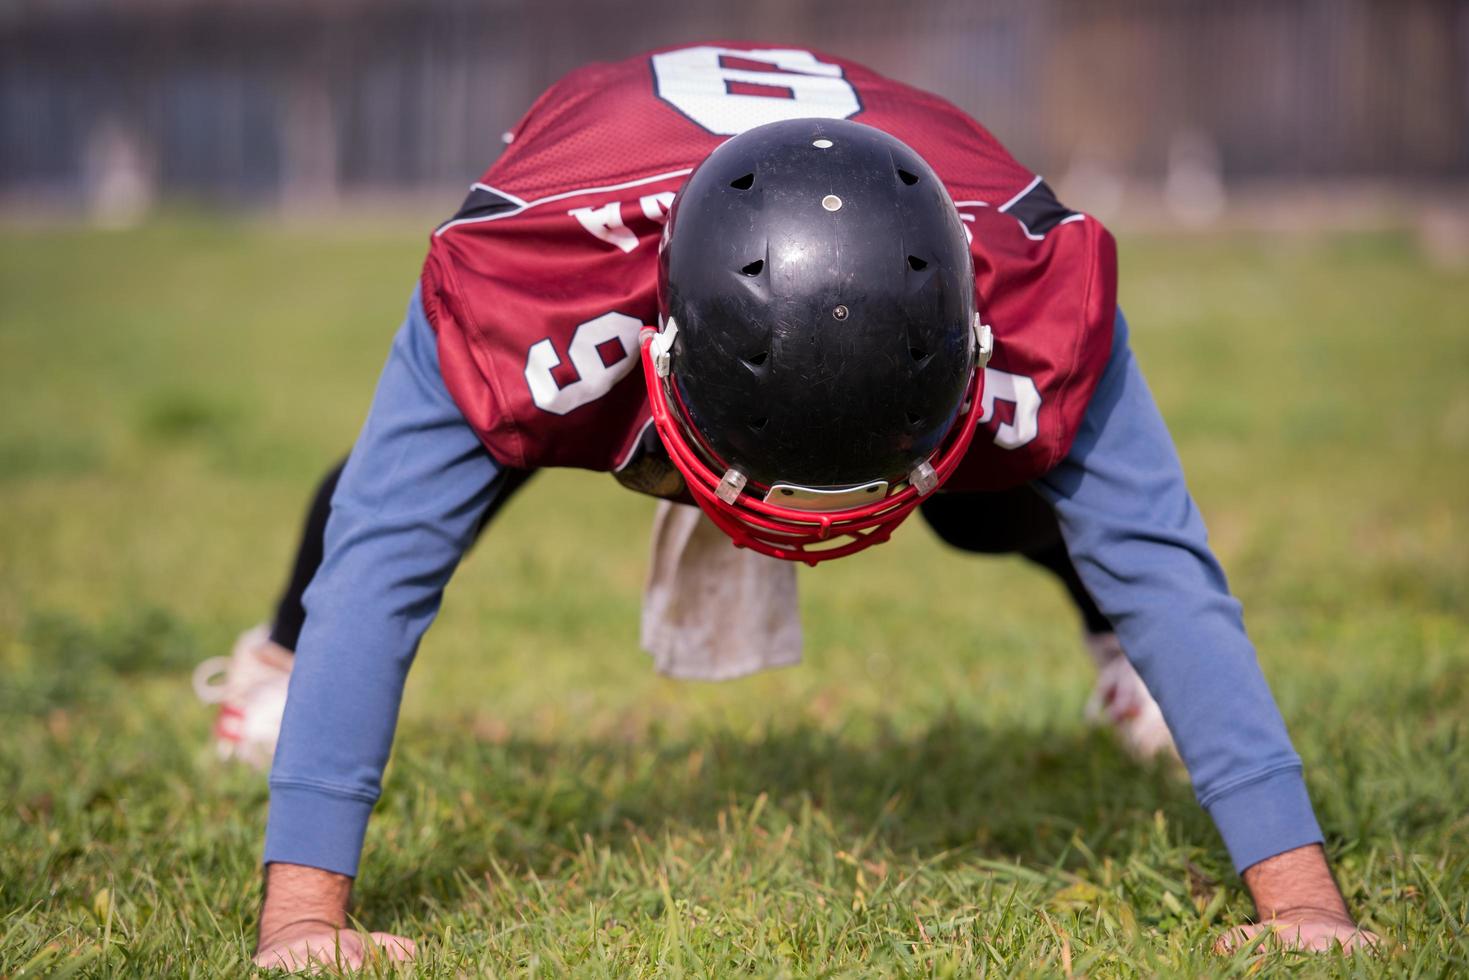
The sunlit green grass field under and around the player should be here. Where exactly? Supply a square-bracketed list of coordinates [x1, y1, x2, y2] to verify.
[0, 217, 1469, 977]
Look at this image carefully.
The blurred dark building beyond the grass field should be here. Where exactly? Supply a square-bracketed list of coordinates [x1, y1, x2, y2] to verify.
[0, 0, 1469, 220]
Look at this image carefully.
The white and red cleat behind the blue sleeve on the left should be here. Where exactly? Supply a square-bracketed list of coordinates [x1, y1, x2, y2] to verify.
[194, 624, 294, 770]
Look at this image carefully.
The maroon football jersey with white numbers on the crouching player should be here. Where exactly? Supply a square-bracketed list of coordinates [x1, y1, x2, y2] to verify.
[422, 43, 1116, 489]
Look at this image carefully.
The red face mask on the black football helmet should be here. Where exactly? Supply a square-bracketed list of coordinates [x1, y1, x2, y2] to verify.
[639, 323, 995, 566]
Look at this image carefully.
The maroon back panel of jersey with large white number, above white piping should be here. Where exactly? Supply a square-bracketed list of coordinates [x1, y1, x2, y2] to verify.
[458, 43, 1031, 208]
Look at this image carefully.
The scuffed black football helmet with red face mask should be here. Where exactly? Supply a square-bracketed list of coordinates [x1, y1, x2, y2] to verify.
[643, 119, 990, 563]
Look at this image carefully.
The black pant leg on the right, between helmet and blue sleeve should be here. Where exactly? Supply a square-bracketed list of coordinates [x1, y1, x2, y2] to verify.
[920, 486, 1112, 633]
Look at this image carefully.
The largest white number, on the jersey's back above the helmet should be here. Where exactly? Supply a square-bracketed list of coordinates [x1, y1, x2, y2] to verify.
[652, 47, 862, 137]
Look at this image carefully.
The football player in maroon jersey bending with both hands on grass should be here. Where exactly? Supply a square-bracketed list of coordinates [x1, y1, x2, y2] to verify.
[226, 44, 1372, 967]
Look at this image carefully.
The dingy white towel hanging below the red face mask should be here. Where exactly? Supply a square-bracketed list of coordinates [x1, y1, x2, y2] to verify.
[642, 501, 801, 680]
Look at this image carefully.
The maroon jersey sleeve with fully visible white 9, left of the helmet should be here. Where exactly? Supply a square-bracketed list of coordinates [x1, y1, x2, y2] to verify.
[423, 178, 673, 470]
